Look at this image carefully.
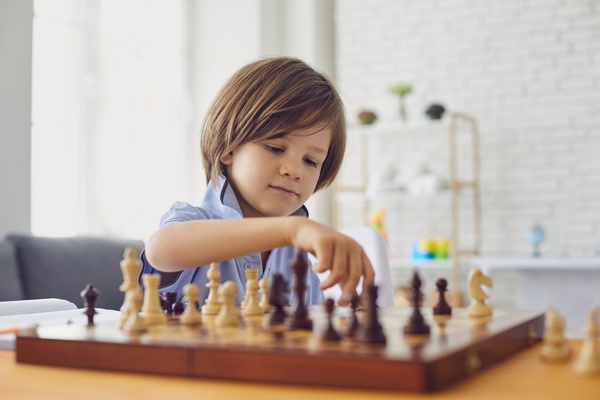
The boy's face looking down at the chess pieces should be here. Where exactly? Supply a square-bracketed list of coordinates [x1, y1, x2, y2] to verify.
[221, 128, 331, 217]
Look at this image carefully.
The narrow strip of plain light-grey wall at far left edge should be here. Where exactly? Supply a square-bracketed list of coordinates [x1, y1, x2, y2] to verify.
[0, 0, 33, 237]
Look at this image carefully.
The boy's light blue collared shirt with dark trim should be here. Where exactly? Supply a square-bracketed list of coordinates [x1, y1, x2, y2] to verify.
[140, 177, 323, 305]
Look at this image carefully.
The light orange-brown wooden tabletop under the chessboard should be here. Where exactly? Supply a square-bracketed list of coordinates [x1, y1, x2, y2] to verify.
[0, 341, 600, 400]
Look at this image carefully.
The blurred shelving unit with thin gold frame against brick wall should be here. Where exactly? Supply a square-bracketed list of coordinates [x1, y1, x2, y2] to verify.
[333, 113, 481, 305]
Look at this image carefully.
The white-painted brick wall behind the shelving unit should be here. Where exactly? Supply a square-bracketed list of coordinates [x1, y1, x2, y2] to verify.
[335, 0, 600, 257]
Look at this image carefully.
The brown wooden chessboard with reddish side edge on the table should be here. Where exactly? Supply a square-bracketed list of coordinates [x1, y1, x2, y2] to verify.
[16, 307, 544, 392]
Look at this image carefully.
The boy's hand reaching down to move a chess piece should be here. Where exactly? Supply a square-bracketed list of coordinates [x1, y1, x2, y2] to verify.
[291, 218, 375, 306]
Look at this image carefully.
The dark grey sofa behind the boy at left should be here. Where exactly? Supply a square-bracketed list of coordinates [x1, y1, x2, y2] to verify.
[0, 234, 144, 310]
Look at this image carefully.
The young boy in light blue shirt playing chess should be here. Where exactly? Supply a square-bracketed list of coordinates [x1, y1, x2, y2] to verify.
[142, 57, 374, 305]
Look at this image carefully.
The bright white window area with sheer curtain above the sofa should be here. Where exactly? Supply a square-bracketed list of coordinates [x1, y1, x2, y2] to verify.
[32, 0, 193, 239]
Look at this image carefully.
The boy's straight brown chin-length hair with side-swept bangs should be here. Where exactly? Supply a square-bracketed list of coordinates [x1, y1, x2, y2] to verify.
[200, 57, 346, 191]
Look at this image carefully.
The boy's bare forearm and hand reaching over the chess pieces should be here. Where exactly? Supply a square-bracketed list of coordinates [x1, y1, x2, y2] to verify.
[145, 217, 374, 304]
